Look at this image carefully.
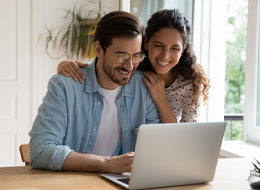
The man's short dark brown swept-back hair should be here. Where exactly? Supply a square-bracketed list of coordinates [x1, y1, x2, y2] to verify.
[95, 11, 144, 51]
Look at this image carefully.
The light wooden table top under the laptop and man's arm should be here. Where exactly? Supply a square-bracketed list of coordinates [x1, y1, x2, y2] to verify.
[0, 158, 251, 190]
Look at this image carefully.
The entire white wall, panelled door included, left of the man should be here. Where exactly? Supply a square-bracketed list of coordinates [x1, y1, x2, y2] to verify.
[0, 0, 119, 167]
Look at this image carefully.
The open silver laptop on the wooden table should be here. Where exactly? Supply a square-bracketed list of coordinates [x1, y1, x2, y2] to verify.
[101, 122, 226, 189]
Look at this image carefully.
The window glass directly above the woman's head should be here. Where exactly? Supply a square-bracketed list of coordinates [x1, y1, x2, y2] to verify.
[130, 0, 193, 26]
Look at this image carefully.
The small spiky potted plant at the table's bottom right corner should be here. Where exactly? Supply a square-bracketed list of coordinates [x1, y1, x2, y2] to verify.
[248, 159, 260, 189]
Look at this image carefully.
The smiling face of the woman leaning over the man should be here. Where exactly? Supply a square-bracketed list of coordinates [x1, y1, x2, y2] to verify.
[145, 28, 183, 75]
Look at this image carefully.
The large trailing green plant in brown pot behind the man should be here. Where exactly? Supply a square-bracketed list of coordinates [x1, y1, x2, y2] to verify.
[44, 0, 105, 60]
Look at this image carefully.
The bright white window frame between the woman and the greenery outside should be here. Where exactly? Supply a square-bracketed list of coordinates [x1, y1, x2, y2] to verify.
[193, 0, 227, 122]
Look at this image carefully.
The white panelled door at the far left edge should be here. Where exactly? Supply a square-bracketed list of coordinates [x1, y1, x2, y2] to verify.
[0, 0, 30, 166]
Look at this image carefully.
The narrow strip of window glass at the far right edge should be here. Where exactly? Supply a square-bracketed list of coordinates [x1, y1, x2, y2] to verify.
[256, 0, 260, 127]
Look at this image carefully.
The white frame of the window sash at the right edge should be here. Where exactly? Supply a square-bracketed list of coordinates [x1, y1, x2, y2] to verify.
[244, 0, 260, 144]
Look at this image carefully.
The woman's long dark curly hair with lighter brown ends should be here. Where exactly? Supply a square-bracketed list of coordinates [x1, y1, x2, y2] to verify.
[138, 9, 210, 103]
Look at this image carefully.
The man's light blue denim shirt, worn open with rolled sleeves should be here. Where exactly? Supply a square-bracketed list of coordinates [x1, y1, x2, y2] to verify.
[29, 63, 161, 170]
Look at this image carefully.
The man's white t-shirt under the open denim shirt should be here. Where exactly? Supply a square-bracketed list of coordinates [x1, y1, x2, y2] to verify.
[92, 87, 122, 156]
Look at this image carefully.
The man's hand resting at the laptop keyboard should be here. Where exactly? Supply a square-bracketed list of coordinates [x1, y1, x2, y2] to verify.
[102, 152, 134, 173]
